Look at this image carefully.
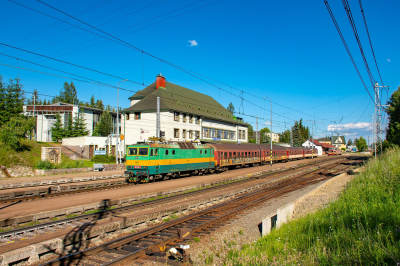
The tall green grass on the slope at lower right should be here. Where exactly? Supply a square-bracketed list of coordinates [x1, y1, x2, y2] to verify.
[225, 148, 400, 265]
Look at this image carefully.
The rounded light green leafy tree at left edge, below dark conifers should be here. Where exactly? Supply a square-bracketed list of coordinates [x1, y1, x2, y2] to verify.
[0, 115, 36, 150]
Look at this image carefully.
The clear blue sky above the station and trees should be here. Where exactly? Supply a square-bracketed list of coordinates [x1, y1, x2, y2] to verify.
[0, 0, 400, 143]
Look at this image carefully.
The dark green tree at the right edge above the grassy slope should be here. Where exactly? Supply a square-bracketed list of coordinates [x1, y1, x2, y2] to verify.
[386, 87, 400, 145]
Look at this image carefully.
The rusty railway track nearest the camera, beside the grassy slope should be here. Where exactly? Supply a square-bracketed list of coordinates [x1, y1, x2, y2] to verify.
[42, 159, 360, 266]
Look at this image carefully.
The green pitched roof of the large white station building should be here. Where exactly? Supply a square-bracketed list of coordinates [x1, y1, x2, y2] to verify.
[122, 82, 245, 125]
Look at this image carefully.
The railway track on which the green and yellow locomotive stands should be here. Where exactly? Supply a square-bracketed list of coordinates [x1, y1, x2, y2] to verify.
[0, 158, 336, 204]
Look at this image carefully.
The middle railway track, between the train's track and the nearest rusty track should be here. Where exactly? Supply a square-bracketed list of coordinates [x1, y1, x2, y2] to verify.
[0, 159, 354, 243]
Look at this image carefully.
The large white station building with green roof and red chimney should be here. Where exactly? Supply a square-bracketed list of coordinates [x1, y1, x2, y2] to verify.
[120, 75, 248, 148]
